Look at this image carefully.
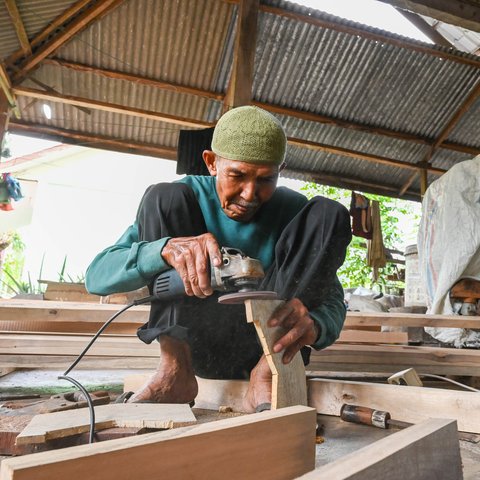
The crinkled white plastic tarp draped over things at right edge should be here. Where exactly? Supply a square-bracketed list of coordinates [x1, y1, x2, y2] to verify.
[418, 155, 480, 347]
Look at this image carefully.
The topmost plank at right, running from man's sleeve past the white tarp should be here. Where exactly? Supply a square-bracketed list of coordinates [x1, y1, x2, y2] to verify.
[345, 312, 480, 329]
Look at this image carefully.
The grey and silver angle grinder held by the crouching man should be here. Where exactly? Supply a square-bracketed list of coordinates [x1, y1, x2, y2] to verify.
[152, 247, 277, 304]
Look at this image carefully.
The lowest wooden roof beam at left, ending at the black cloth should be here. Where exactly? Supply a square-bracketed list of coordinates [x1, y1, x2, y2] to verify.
[9, 121, 177, 160]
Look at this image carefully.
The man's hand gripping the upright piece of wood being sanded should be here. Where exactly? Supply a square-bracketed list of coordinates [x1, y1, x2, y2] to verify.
[268, 298, 319, 363]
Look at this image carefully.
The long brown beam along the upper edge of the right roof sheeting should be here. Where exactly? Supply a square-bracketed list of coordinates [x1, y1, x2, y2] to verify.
[260, 0, 480, 68]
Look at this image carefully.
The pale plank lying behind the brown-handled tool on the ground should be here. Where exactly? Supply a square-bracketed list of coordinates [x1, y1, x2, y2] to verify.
[308, 378, 480, 433]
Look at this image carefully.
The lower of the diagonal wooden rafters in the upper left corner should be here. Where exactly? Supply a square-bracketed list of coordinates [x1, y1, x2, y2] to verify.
[13, 0, 123, 83]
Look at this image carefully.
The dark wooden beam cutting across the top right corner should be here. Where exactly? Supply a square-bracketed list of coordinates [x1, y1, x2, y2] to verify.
[380, 0, 480, 32]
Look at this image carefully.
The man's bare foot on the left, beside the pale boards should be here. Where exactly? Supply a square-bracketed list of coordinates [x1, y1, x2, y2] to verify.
[128, 335, 198, 403]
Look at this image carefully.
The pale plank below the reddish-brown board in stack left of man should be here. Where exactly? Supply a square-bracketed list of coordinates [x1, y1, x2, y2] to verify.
[0, 332, 159, 358]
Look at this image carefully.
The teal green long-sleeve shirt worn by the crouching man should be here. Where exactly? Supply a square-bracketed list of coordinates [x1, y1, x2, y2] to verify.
[86, 176, 345, 349]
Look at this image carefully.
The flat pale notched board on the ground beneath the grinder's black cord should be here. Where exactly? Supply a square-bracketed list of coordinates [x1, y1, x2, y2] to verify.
[17, 403, 197, 445]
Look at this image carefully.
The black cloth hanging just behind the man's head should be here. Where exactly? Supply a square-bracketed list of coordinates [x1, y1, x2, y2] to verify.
[177, 127, 214, 175]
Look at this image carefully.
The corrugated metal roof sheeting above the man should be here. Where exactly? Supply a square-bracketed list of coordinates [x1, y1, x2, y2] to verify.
[0, 0, 480, 200]
